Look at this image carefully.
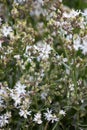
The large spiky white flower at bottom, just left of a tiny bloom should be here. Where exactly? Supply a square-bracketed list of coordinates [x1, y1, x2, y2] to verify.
[44, 108, 58, 123]
